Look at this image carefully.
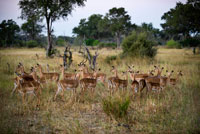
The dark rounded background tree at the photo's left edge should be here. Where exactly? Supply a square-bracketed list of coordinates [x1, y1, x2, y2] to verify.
[0, 19, 20, 46]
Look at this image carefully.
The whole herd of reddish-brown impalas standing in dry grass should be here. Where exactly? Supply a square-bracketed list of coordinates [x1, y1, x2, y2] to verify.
[12, 61, 182, 105]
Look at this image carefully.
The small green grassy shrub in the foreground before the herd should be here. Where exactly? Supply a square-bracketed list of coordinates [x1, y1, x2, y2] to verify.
[102, 96, 130, 120]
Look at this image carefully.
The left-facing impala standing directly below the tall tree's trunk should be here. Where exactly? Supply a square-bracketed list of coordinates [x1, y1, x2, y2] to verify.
[36, 64, 60, 82]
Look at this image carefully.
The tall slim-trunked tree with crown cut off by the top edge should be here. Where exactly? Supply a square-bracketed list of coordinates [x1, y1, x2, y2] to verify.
[19, 0, 86, 57]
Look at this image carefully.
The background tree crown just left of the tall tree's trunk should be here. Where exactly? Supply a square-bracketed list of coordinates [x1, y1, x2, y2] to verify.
[21, 18, 44, 40]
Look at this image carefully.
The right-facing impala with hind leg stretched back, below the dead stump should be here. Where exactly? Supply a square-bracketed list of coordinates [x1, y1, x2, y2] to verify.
[54, 70, 80, 100]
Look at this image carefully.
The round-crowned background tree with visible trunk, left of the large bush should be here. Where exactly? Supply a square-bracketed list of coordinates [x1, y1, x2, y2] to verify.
[104, 7, 132, 48]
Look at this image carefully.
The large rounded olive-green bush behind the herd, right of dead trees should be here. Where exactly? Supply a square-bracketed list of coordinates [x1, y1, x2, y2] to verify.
[122, 31, 156, 57]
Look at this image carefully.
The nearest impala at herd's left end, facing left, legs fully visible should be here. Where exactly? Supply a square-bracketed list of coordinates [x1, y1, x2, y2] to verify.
[13, 73, 41, 106]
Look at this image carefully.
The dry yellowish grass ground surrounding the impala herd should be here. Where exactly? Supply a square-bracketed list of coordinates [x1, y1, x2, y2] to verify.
[0, 48, 200, 133]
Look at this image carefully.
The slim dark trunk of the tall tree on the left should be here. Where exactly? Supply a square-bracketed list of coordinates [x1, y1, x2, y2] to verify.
[46, 19, 52, 57]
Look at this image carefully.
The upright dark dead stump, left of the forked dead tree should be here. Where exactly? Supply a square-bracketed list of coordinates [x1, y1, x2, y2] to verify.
[63, 46, 73, 69]
